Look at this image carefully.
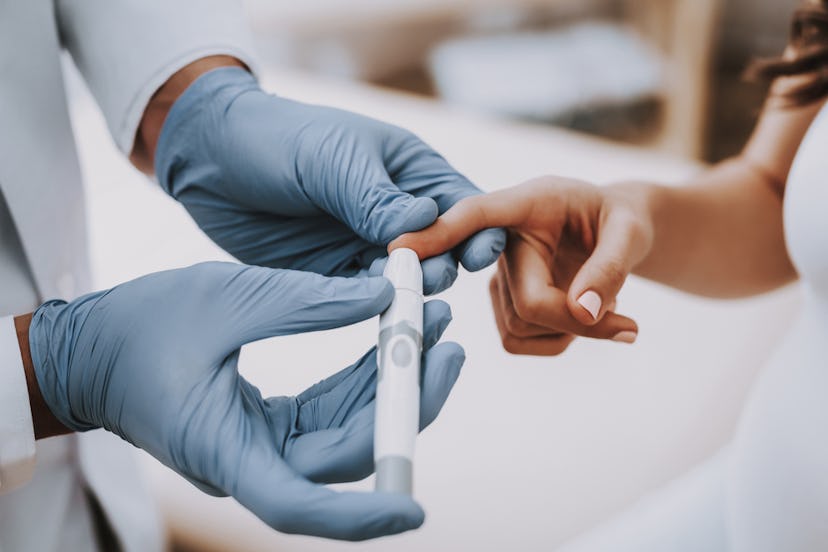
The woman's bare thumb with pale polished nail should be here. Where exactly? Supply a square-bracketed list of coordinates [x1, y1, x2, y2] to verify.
[567, 211, 649, 325]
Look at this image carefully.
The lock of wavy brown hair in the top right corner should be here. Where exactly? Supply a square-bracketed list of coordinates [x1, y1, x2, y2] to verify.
[745, 0, 828, 105]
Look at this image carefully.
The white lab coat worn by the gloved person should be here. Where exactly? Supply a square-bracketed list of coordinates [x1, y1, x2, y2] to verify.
[0, 0, 254, 552]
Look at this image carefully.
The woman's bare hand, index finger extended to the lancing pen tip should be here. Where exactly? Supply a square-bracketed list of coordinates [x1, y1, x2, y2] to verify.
[389, 177, 653, 355]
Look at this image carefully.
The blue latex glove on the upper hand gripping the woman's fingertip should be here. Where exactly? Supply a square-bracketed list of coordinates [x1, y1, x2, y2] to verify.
[155, 67, 505, 293]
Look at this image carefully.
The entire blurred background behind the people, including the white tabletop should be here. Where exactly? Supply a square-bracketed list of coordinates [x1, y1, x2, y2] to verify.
[67, 0, 799, 552]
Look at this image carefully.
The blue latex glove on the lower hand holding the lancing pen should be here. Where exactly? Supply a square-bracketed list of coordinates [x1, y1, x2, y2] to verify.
[29, 263, 464, 540]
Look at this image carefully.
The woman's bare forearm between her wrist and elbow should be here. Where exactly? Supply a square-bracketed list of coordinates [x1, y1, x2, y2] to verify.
[628, 157, 796, 297]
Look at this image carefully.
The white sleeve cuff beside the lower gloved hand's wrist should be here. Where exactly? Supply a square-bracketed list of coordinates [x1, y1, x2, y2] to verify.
[0, 316, 35, 494]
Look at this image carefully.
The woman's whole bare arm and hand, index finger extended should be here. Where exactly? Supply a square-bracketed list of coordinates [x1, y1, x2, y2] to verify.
[389, 77, 823, 354]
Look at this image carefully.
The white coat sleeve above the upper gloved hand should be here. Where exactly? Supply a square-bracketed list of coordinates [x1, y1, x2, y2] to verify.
[57, 0, 256, 154]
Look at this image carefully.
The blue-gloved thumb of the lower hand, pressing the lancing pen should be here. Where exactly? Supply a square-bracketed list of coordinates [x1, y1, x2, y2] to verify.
[221, 266, 394, 348]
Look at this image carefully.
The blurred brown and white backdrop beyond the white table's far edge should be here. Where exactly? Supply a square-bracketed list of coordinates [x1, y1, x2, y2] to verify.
[247, 0, 797, 161]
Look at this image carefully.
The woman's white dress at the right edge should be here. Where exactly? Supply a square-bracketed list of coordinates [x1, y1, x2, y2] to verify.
[561, 104, 828, 552]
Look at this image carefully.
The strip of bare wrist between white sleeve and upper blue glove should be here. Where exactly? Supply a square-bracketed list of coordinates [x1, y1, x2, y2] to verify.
[129, 55, 247, 174]
